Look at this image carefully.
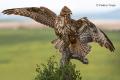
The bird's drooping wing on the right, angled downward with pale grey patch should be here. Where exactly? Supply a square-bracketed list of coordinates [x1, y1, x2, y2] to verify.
[78, 18, 115, 52]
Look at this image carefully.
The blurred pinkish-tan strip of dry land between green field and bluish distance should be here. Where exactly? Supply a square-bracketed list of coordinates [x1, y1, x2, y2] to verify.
[0, 20, 120, 30]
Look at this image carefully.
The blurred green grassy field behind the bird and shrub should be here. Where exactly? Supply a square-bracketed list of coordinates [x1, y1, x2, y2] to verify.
[0, 29, 120, 80]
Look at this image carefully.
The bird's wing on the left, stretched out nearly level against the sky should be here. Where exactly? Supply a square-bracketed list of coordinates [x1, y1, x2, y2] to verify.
[2, 7, 56, 27]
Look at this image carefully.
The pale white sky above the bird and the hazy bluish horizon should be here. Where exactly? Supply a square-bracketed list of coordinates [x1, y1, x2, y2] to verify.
[0, 0, 120, 19]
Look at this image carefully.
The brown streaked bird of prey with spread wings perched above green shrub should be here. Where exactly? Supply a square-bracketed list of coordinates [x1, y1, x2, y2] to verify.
[2, 6, 115, 64]
